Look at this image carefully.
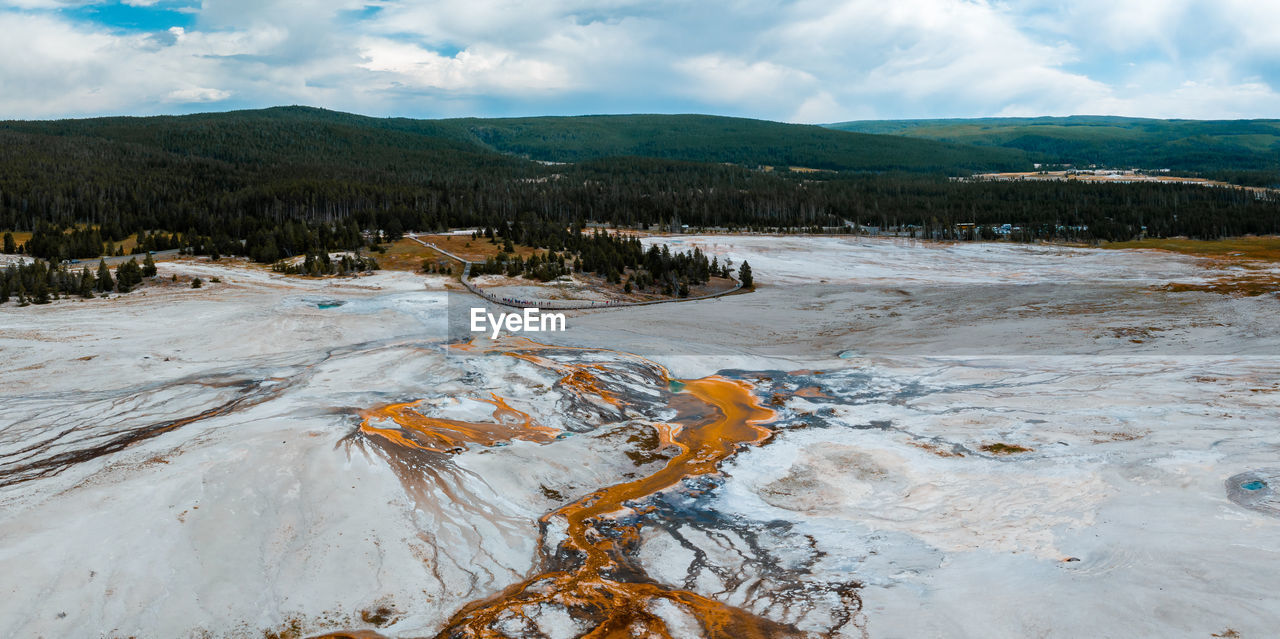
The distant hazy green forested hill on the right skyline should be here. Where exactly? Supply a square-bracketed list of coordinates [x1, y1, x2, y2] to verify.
[828, 115, 1280, 186]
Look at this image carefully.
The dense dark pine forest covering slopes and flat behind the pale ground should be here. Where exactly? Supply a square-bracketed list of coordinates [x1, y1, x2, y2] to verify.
[0, 108, 1280, 268]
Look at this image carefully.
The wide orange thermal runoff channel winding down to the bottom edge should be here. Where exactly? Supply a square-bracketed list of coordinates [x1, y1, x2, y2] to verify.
[440, 376, 799, 639]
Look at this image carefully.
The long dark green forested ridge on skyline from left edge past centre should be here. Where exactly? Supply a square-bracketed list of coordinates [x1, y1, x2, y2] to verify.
[0, 106, 1030, 174]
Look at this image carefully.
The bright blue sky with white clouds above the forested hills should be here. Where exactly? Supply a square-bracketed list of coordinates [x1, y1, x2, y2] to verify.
[0, 0, 1280, 123]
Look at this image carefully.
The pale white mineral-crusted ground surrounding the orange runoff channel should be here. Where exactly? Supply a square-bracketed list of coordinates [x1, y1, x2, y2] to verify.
[0, 236, 1280, 638]
